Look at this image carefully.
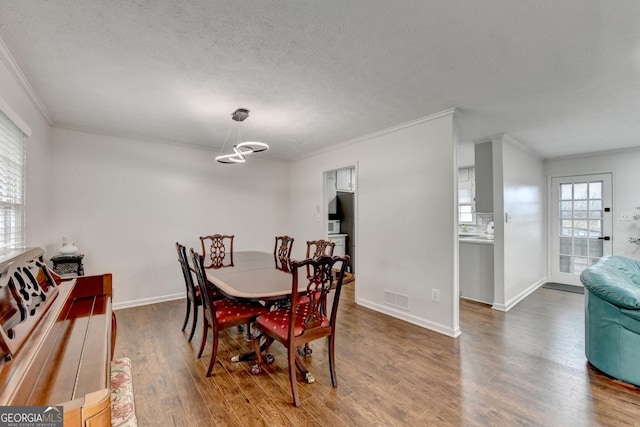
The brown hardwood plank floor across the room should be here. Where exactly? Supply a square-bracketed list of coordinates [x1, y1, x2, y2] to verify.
[115, 284, 640, 427]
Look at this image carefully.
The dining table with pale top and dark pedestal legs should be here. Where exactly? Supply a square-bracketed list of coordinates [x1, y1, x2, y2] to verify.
[205, 251, 354, 382]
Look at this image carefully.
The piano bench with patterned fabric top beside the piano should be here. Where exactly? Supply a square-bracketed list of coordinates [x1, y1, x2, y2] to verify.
[111, 357, 138, 427]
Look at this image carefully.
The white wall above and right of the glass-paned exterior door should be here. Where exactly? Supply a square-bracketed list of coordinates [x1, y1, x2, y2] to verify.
[545, 149, 640, 259]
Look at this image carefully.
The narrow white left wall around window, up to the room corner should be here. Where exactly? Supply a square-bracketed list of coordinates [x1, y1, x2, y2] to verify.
[0, 51, 51, 246]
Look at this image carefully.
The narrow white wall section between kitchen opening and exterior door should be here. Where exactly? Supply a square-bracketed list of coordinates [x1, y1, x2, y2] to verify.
[492, 135, 547, 311]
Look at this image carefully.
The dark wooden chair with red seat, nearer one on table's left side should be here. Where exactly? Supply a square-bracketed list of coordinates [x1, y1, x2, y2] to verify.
[191, 248, 268, 377]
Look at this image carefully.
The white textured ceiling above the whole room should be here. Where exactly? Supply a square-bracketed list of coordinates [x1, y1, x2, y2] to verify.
[0, 0, 640, 160]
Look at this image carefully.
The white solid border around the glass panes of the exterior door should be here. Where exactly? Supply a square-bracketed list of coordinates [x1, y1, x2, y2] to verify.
[547, 172, 614, 286]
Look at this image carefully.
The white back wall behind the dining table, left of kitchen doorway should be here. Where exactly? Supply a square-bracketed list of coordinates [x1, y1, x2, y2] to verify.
[46, 128, 291, 307]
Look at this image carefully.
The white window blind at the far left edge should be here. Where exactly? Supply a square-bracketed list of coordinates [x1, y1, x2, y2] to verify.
[0, 111, 25, 249]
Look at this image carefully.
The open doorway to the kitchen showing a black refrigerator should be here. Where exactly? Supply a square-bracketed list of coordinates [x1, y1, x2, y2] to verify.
[324, 166, 356, 273]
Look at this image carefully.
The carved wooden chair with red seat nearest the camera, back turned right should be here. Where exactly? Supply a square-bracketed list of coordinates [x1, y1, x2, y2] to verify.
[252, 255, 349, 406]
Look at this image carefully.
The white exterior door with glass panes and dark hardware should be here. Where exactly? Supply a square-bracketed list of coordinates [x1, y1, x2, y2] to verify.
[550, 174, 612, 286]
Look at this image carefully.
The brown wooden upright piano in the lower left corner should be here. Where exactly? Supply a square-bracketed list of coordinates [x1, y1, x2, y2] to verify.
[0, 248, 116, 427]
